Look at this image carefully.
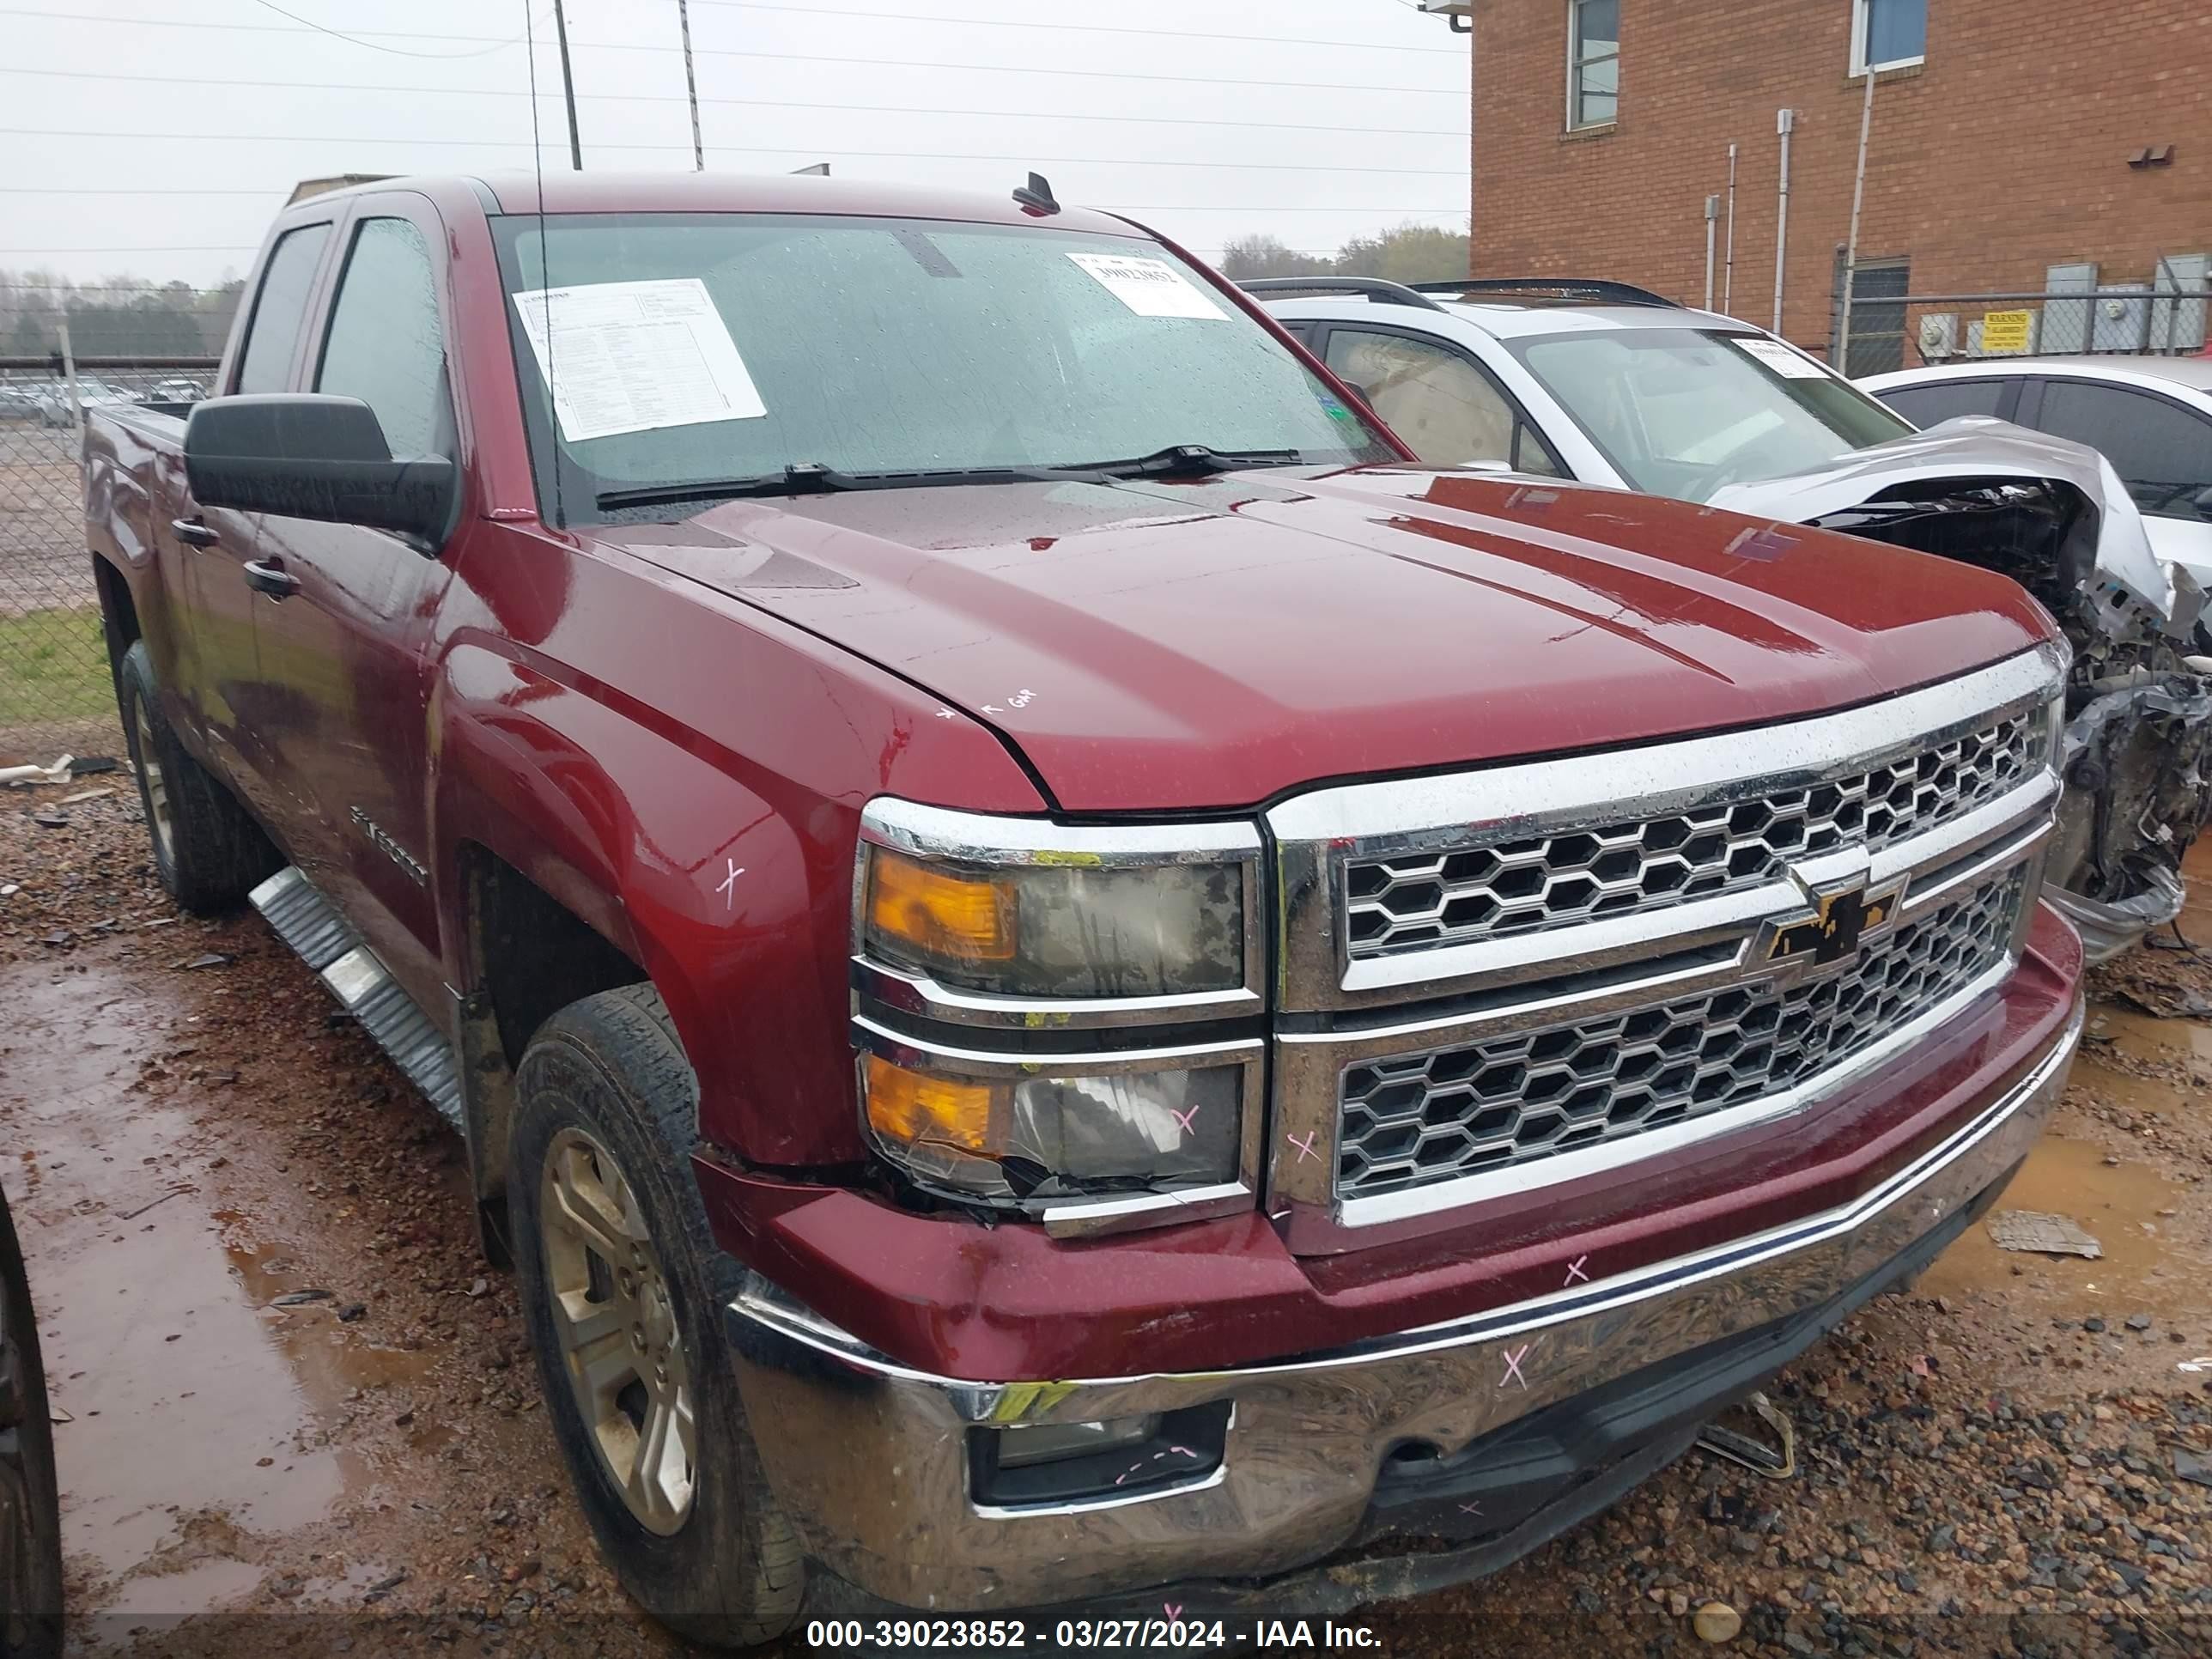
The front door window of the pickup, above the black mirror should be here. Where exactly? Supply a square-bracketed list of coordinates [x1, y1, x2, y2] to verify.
[314, 219, 453, 460]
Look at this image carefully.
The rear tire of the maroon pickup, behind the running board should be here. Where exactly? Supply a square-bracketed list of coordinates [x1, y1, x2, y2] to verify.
[115, 639, 283, 915]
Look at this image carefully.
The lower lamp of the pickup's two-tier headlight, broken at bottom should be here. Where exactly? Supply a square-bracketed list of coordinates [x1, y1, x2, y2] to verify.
[860, 1053, 1245, 1199]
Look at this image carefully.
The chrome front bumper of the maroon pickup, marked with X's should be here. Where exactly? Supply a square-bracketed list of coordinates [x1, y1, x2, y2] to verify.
[726, 1005, 2081, 1610]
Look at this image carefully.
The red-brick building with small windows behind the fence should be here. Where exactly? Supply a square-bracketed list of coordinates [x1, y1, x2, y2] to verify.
[1429, 0, 2212, 372]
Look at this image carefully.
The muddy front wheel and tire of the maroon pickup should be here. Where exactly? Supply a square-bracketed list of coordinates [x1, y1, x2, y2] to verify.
[507, 984, 805, 1648]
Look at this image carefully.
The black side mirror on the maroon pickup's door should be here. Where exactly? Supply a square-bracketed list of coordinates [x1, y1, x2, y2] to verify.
[184, 392, 460, 553]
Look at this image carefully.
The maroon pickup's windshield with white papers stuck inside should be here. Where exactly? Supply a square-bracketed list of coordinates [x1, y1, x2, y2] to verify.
[493, 212, 1395, 518]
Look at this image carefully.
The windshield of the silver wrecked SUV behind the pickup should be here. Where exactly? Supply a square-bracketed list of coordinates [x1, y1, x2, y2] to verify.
[1509, 327, 1911, 502]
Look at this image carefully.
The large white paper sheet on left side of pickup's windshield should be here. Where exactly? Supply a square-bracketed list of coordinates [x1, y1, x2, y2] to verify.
[515, 276, 768, 442]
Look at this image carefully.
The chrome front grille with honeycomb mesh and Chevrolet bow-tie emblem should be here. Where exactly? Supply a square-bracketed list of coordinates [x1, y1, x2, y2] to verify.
[1267, 644, 2069, 1252]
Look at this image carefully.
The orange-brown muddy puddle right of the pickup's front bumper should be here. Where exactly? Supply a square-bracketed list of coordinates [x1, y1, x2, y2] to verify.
[1916, 1132, 2212, 1325]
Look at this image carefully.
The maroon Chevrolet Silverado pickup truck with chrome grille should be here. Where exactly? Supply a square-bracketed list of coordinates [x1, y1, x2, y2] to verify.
[86, 175, 2079, 1646]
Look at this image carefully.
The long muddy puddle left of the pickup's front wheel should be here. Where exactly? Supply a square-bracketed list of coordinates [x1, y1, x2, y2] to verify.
[0, 964, 427, 1613]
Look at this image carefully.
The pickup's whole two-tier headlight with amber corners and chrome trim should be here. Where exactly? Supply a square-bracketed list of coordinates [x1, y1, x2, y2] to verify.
[854, 799, 1263, 1230]
